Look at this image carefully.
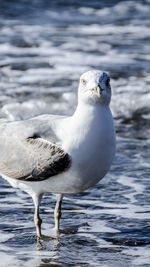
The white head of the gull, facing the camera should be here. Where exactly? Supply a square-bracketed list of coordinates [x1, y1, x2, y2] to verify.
[78, 70, 111, 105]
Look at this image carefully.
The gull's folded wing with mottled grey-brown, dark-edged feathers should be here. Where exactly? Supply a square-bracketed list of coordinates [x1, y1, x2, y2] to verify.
[0, 136, 71, 182]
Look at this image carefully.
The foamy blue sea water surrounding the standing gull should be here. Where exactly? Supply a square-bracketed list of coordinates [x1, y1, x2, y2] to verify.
[0, 0, 150, 267]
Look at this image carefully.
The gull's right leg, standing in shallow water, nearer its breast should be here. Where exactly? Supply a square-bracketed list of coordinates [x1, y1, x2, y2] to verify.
[54, 194, 63, 233]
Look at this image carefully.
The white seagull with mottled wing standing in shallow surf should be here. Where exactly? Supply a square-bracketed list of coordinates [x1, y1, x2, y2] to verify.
[0, 70, 115, 238]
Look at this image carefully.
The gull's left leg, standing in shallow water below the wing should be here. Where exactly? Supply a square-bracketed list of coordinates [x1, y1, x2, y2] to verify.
[33, 195, 42, 237]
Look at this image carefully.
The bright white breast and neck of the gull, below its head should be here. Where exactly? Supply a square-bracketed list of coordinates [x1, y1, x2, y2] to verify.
[59, 102, 115, 191]
